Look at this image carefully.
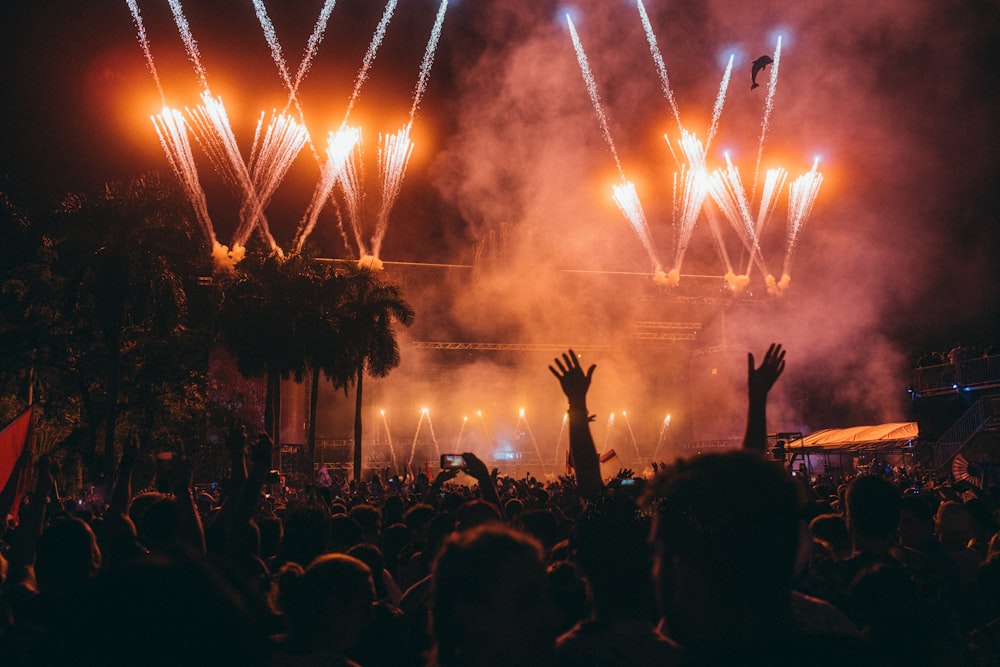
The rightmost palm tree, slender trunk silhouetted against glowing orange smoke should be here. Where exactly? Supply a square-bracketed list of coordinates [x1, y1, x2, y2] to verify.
[340, 268, 414, 481]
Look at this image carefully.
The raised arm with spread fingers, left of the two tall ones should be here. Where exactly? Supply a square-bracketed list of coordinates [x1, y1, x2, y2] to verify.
[549, 350, 604, 496]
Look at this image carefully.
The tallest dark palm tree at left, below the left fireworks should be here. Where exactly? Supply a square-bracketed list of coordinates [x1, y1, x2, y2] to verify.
[55, 177, 203, 480]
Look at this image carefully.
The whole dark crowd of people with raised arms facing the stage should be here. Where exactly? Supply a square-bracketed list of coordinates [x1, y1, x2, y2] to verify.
[0, 345, 1000, 667]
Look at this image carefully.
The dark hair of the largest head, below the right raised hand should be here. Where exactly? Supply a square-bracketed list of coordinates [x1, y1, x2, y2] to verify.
[645, 450, 799, 601]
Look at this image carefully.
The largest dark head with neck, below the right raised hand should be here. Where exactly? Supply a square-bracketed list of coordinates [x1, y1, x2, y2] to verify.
[646, 451, 799, 643]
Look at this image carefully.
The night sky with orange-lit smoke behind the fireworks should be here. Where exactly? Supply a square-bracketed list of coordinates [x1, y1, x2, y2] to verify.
[0, 0, 1000, 434]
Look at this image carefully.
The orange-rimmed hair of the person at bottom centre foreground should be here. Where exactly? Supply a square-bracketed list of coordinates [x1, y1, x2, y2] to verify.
[430, 523, 545, 666]
